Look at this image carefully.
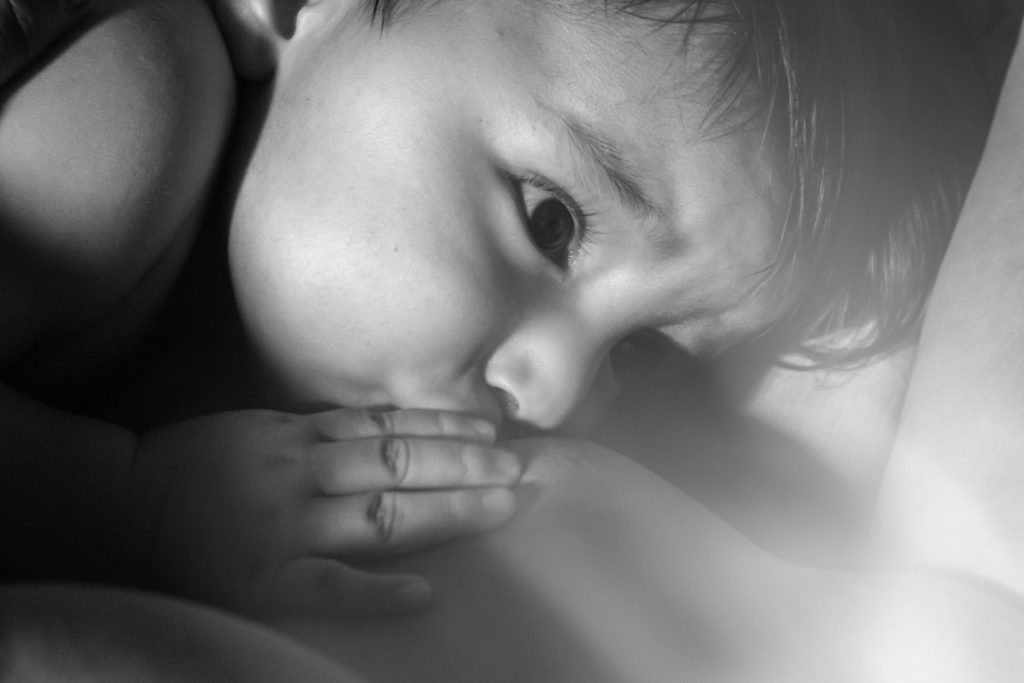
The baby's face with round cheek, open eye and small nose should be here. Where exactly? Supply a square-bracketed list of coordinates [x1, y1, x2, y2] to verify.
[230, 0, 780, 428]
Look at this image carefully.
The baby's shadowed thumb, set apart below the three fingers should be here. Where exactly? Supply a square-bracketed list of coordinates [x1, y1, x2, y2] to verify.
[269, 557, 431, 616]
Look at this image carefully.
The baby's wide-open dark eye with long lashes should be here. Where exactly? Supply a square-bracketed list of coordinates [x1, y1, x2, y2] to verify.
[516, 176, 587, 268]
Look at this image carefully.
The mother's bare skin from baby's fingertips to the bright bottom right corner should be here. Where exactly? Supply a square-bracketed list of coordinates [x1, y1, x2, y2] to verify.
[276, 439, 1024, 683]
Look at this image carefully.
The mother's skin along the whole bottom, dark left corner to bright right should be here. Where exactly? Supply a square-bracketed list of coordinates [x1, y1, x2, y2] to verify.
[8, 440, 1024, 683]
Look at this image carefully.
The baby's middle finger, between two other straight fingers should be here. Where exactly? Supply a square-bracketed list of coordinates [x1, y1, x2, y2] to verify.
[309, 436, 522, 496]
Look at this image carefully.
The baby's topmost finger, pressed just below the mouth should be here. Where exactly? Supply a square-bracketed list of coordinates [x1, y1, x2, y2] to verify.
[312, 409, 497, 443]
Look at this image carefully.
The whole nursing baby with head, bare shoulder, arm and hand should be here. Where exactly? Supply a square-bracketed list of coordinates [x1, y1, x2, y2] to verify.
[0, 0, 990, 613]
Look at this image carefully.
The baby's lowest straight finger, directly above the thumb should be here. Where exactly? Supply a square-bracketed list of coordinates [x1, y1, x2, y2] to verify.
[303, 488, 515, 556]
